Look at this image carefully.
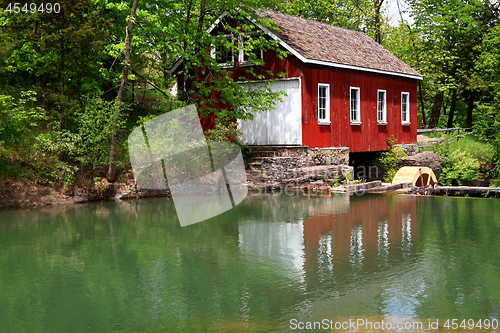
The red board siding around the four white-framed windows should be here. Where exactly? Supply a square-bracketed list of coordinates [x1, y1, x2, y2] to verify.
[302, 66, 417, 152]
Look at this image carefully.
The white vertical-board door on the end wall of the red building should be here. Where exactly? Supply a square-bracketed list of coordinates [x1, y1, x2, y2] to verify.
[238, 79, 302, 145]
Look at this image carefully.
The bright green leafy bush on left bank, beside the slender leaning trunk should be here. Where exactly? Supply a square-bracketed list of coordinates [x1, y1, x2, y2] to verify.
[77, 96, 128, 170]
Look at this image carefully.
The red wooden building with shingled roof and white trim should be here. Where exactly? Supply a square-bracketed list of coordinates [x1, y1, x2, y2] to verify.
[172, 10, 422, 152]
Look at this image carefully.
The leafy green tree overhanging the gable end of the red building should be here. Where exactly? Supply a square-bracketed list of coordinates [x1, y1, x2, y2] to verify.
[158, 0, 285, 123]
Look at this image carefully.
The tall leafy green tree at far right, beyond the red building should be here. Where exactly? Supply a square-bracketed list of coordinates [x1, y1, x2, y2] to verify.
[404, 0, 495, 127]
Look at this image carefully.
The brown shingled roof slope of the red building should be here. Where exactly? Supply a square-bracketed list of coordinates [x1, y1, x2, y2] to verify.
[257, 10, 422, 77]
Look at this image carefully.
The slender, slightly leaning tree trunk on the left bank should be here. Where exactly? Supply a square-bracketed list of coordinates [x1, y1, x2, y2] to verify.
[108, 0, 138, 182]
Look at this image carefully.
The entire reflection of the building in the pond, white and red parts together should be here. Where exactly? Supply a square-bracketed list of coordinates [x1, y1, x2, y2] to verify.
[238, 195, 417, 282]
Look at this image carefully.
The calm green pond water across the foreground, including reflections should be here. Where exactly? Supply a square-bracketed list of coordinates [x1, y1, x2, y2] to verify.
[0, 193, 500, 332]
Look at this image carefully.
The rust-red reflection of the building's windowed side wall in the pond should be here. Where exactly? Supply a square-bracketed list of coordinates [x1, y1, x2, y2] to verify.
[303, 195, 417, 271]
